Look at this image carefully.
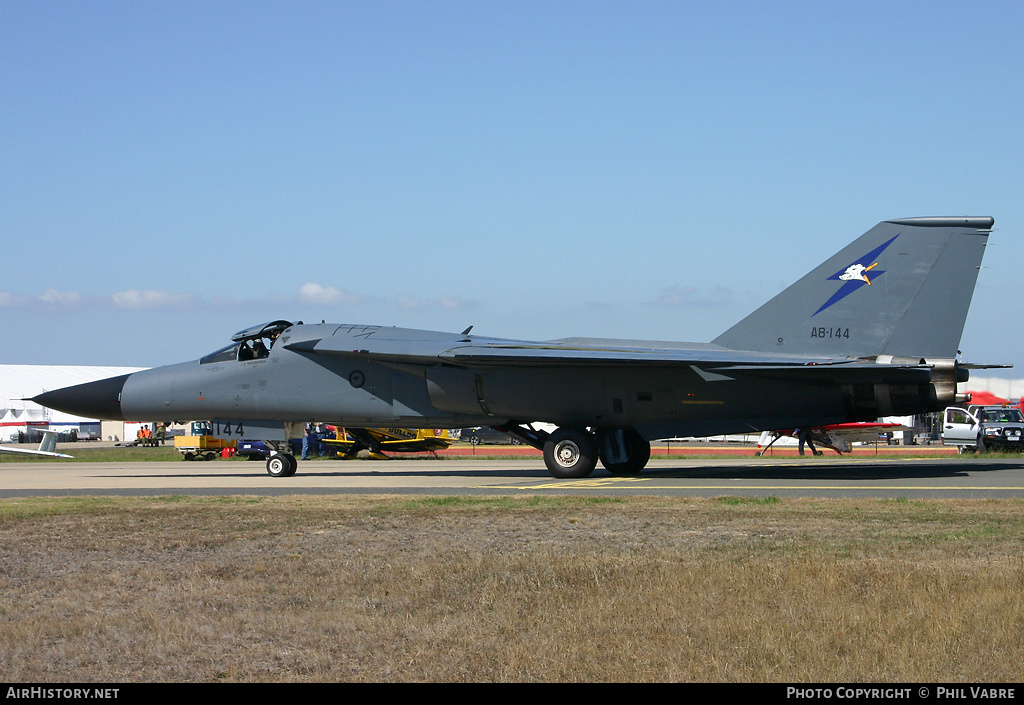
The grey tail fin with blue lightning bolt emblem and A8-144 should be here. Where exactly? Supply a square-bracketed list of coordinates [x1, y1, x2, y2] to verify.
[713, 217, 994, 358]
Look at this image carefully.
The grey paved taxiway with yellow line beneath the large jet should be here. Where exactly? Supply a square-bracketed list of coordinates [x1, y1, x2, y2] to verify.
[0, 455, 1024, 498]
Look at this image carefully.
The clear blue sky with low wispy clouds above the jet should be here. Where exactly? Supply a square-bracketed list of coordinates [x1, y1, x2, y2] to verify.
[0, 0, 1024, 376]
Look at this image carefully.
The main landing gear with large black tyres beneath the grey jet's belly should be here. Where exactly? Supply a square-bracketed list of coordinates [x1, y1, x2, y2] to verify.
[499, 423, 650, 479]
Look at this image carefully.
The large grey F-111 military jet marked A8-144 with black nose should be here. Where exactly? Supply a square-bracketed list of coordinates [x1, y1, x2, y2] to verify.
[34, 217, 994, 478]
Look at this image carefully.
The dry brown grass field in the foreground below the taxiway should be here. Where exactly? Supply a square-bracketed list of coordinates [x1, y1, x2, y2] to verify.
[0, 496, 1024, 682]
